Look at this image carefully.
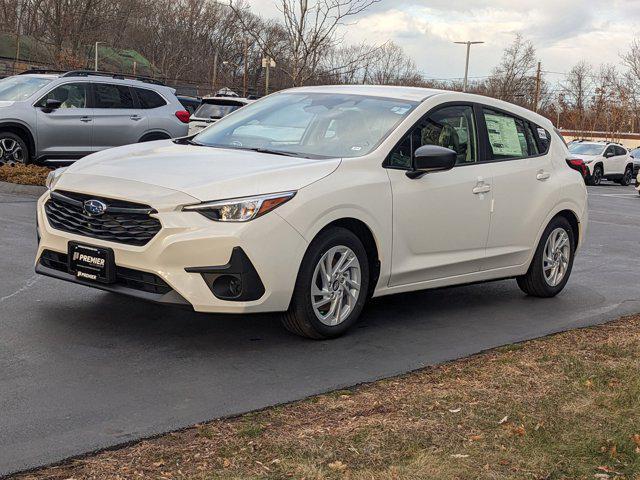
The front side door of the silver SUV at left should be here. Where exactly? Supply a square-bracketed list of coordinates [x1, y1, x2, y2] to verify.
[34, 82, 94, 159]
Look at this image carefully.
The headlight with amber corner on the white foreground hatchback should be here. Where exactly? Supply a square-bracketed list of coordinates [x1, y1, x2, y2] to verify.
[182, 192, 296, 222]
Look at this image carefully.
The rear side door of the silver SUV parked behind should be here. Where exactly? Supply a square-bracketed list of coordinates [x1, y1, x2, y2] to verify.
[93, 82, 149, 151]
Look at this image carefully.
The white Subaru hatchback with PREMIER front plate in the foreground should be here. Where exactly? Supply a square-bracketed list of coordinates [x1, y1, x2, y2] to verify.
[36, 86, 587, 338]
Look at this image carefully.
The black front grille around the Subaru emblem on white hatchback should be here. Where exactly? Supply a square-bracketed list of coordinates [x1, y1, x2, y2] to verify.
[45, 191, 162, 246]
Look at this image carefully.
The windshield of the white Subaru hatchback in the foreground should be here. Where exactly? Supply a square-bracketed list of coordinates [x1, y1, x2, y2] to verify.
[193, 92, 418, 158]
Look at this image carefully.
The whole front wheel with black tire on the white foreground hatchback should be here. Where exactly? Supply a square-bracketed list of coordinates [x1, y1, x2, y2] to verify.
[282, 228, 369, 340]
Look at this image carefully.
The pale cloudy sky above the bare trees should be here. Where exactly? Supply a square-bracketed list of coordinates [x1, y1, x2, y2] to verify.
[241, 0, 640, 82]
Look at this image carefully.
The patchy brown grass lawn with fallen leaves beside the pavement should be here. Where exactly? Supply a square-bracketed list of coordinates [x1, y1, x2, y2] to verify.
[11, 316, 640, 480]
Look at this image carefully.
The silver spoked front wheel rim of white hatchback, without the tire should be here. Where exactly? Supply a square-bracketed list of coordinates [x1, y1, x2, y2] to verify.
[310, 245, 362, 326]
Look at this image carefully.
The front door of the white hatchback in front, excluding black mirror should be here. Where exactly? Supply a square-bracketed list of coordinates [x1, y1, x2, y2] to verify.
[385, 104, 492, 286]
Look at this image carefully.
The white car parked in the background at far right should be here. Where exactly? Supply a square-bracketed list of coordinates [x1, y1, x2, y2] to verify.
[569, 141, 633, 185]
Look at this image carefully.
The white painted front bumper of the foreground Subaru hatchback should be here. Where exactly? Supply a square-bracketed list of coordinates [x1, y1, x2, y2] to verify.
[36, 192, 307, 313]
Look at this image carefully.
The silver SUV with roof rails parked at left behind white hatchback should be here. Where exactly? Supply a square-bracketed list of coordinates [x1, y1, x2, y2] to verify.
[0, 71, 189, 163]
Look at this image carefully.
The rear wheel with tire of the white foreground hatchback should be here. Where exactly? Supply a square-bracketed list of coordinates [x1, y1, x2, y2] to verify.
[517, 217, 576, 298]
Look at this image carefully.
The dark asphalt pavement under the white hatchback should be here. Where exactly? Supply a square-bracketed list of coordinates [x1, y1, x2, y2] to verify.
[0, 185, 640, 475]
